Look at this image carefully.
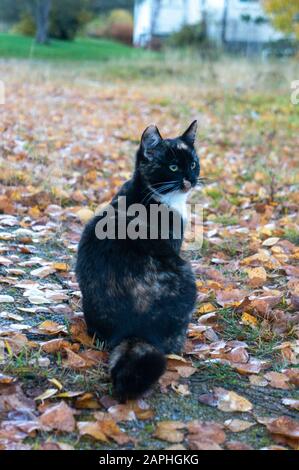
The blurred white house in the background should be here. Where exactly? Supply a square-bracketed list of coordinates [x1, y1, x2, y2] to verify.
[134, 0, 282, 46]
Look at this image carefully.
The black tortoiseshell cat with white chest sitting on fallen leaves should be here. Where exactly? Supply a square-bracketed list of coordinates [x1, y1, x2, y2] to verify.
[76, 121, 200, 403]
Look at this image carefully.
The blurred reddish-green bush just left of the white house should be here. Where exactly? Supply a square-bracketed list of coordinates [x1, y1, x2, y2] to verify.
[85, 10, 133, 44]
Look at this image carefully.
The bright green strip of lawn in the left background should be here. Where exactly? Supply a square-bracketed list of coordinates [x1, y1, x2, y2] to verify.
[0, 34, 148, 61]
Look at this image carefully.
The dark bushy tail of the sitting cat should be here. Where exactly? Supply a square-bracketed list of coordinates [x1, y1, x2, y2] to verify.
[110, 338, 166, 403]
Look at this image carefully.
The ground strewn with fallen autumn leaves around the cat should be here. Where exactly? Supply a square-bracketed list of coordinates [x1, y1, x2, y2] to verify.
[0, 50, 299, 450]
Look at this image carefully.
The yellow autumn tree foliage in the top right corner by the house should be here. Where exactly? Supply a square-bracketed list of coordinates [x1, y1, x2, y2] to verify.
[264, 0, 299, 39]
